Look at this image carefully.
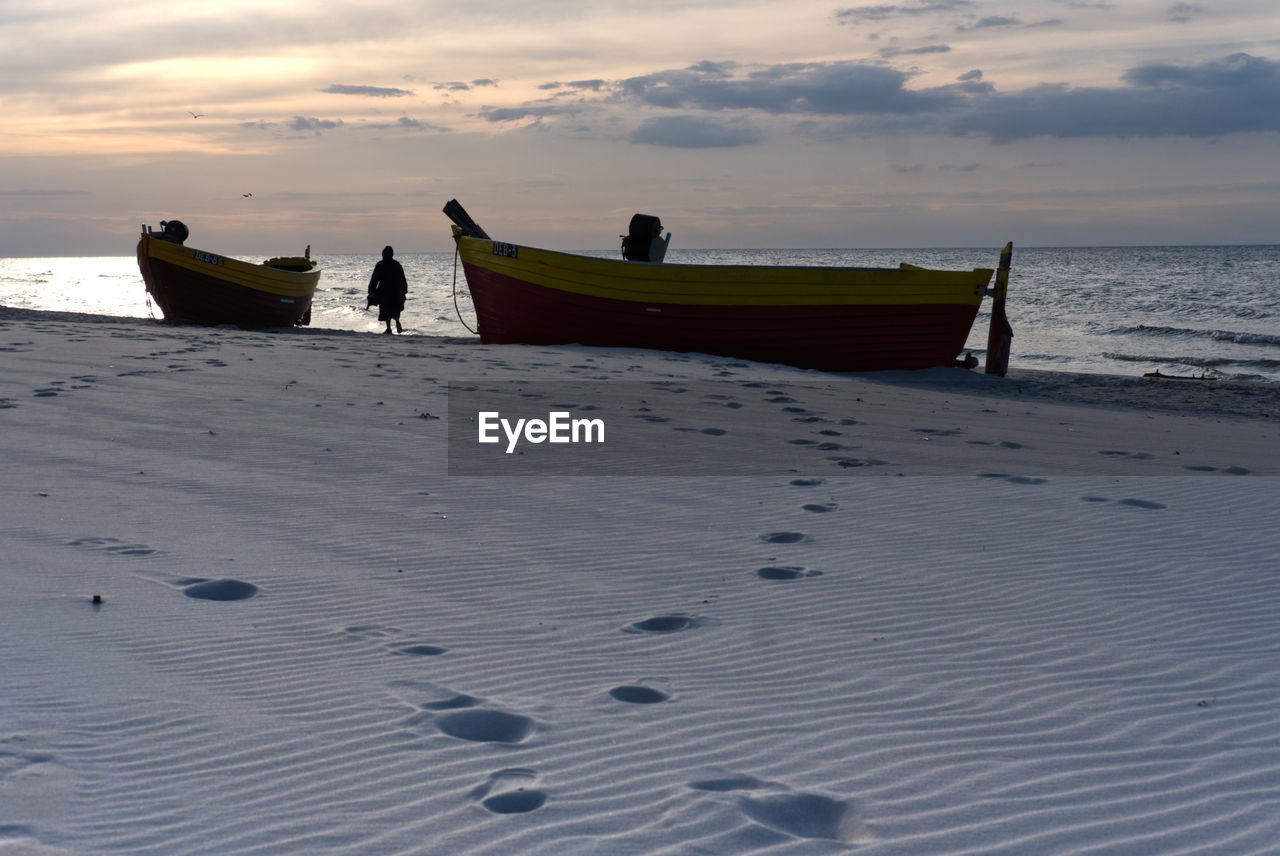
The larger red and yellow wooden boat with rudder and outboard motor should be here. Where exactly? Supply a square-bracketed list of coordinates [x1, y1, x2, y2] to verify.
[444, 200, 1012, 375]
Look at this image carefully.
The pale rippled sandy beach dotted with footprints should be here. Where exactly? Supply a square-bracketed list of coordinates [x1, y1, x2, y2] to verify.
[0, 308, 1280, 856]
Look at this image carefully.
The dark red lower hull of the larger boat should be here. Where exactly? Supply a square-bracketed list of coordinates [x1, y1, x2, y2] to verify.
[463, 262, 978, 371]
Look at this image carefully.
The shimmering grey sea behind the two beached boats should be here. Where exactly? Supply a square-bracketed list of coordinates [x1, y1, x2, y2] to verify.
[0, 246, 1280, 383]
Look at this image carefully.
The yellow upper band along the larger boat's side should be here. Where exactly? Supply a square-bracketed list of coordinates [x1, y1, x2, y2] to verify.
[454, 228, 995, 306]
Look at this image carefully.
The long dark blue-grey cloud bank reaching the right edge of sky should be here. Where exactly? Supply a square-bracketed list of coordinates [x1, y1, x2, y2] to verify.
[614, 52, 1280, 143]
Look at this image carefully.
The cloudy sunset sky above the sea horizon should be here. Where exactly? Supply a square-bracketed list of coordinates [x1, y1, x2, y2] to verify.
[0, 0, 1280, 257]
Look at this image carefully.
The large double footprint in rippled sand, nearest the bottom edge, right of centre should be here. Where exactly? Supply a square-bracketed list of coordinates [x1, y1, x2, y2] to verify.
[689, 774, 865, 843]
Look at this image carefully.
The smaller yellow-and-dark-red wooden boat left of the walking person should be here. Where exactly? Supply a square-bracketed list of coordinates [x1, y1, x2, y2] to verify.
[138, 220, 320, 328]
